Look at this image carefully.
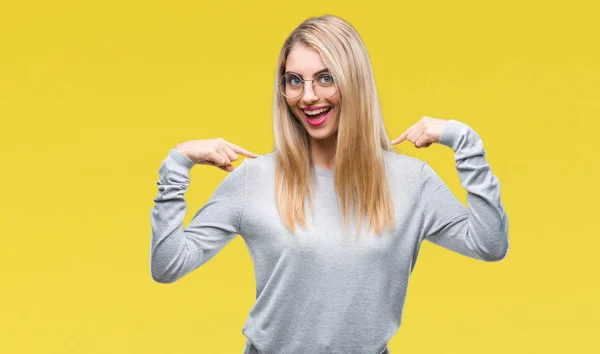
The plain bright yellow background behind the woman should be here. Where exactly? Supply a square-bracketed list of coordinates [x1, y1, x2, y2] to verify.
[0, 0, 600, 354]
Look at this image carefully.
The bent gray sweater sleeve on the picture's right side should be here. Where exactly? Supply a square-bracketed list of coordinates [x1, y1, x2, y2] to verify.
[420, 120, 509, 262]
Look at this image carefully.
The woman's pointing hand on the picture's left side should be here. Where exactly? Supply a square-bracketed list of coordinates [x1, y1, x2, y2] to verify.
[175, 138, 258, 172]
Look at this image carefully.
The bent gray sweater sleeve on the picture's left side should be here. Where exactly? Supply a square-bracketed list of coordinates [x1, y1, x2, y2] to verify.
[150, 149, 246, 283]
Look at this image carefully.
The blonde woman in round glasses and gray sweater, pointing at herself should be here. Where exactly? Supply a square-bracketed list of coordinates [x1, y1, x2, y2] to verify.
[150, 16, 509, 354]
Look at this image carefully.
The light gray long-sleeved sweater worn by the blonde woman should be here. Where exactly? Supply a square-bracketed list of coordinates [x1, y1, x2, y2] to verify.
[150, 120, 509, 354]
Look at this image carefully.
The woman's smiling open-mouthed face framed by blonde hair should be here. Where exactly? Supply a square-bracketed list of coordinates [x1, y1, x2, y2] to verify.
[285, 44, 341, 140]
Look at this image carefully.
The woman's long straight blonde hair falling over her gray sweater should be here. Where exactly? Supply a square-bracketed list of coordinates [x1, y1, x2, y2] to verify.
[273, 15, 394, 238]
